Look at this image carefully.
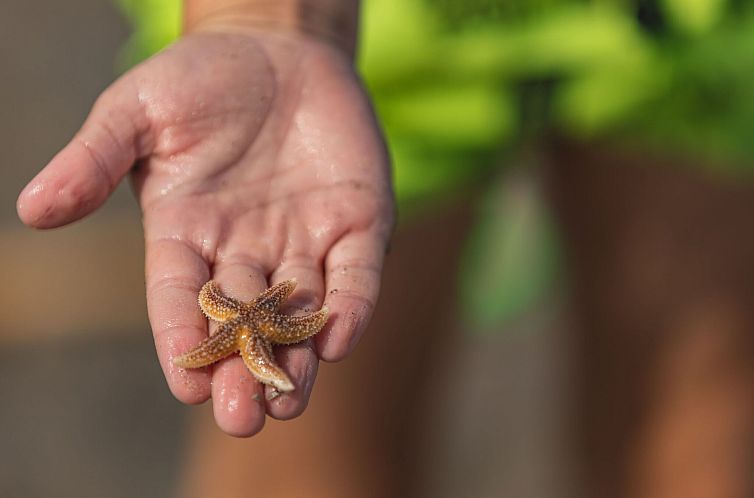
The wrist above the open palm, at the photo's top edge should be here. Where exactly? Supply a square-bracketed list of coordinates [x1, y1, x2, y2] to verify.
[183, 0, 359, 58]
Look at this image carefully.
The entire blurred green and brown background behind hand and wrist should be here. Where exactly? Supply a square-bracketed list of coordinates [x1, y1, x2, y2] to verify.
[0, 0, 754, 498]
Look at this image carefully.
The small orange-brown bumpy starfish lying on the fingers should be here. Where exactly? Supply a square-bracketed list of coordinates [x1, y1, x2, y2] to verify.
[173, 278, 328, 392]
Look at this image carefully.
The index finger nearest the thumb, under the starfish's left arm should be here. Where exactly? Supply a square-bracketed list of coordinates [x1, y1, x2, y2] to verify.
[146, 239, 210, 403]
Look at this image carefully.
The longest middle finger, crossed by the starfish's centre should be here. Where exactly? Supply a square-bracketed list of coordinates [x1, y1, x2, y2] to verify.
[212, 259, 267, 437]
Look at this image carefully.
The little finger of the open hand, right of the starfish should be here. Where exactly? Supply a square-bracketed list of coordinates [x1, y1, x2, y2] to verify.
[315, 230, 385, 361]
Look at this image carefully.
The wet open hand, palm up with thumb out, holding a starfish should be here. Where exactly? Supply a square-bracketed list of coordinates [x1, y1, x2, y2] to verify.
[18, 32, 393, 436]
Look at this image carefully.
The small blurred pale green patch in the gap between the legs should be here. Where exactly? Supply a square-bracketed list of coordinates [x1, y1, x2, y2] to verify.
[460, 170, 559, 332]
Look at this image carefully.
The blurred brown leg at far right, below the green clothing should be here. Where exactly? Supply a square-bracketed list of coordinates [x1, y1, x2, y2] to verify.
[551, 139, 754, 498]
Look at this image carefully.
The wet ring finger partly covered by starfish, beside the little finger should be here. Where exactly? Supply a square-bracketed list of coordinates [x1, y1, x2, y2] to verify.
[265, 256, 324, 420]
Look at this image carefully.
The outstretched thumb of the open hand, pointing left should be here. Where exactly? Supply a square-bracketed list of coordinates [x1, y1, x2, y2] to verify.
[16, 78, 150, 228]
